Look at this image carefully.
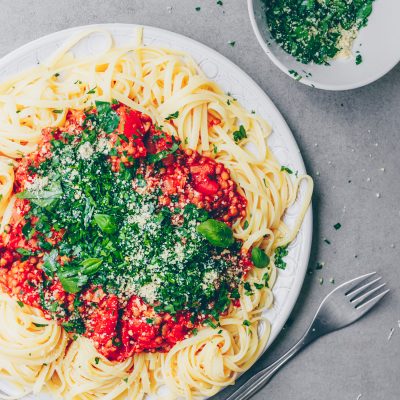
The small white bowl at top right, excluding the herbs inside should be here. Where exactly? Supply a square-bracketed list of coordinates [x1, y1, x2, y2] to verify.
[247, 0, 400, 90]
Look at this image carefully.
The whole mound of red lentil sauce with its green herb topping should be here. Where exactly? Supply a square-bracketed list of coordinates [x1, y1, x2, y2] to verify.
[0, 101, 260, 361]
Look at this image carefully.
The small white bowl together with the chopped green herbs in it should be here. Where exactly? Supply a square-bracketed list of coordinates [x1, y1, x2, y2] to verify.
[248, 0, 400, 90]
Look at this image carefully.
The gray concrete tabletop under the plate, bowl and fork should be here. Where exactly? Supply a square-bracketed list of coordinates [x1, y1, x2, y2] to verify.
[0, 0, 400, 400]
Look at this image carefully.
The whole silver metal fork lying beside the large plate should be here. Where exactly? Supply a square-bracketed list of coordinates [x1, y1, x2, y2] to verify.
[226, 272, 390, 400]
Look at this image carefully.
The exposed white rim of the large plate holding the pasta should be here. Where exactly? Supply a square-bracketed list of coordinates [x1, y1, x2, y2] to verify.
[0, 24, 312, 400]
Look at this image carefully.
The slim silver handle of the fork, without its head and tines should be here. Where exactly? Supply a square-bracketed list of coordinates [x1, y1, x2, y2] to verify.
[226, 329, 318, 400]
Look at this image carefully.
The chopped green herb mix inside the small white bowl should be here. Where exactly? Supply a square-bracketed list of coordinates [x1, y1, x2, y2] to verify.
[263, 0, 374, 64]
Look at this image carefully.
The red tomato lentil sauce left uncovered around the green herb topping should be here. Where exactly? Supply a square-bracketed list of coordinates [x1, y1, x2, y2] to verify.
[0, 104, 252, 361]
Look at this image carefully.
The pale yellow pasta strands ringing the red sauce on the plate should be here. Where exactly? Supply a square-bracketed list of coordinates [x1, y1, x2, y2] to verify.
[0, 31, 313, 400]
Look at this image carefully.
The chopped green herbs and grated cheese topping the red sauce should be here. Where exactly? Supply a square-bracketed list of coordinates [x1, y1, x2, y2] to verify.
[18, 101, 244, 324]
